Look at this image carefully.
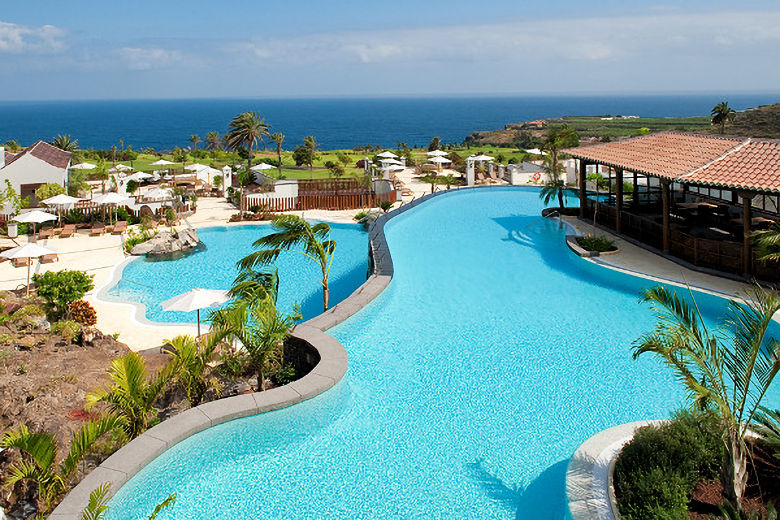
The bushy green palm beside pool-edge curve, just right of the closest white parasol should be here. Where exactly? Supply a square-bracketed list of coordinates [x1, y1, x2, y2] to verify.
[212, 294, 298, 392]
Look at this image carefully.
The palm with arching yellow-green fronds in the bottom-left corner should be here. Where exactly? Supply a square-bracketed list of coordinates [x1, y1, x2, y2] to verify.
[0, 415, 126, 512]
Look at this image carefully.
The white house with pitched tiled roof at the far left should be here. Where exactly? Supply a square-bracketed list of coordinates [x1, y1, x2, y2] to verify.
[0, 141, 72, 206]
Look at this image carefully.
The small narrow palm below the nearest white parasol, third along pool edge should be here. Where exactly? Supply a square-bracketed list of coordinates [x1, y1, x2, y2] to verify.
[166, 334, 219, 407]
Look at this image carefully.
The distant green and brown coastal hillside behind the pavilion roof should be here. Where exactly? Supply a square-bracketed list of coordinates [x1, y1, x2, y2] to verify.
[464, 103, 780, 148]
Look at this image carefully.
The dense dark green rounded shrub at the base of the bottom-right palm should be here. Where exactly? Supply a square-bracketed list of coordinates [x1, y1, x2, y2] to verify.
[615, 411, 725, 520]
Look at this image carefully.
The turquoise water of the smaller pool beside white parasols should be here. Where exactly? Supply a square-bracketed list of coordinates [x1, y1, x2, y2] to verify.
[107, 224, 368, 323]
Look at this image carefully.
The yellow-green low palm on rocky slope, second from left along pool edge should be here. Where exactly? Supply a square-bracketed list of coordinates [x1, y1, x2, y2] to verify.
[86, 352, 175, 439]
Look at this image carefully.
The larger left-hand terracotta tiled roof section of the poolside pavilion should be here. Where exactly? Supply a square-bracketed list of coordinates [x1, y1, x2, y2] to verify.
[564, 132, 743, 179]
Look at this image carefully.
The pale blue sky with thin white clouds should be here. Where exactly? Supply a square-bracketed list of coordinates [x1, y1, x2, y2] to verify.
[0, 0, 780, 101]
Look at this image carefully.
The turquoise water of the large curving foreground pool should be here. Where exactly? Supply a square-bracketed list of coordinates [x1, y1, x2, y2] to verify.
[103, 188, 780, 520]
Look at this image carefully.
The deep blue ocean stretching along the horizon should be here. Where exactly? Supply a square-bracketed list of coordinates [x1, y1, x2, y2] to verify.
[0, 94, 780, 151]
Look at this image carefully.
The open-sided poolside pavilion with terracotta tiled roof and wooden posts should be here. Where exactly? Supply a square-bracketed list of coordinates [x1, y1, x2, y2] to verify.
[565, 132, 780, 275]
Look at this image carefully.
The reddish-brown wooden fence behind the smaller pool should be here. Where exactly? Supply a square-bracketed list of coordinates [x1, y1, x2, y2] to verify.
[241, 190, 397, 213]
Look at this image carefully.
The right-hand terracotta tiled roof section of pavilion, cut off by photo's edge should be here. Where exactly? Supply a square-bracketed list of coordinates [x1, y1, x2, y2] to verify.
[681, 139, 780, 192]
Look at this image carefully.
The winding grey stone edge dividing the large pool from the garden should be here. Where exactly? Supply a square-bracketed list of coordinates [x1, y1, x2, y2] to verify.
[48, 212, 412, 520]
